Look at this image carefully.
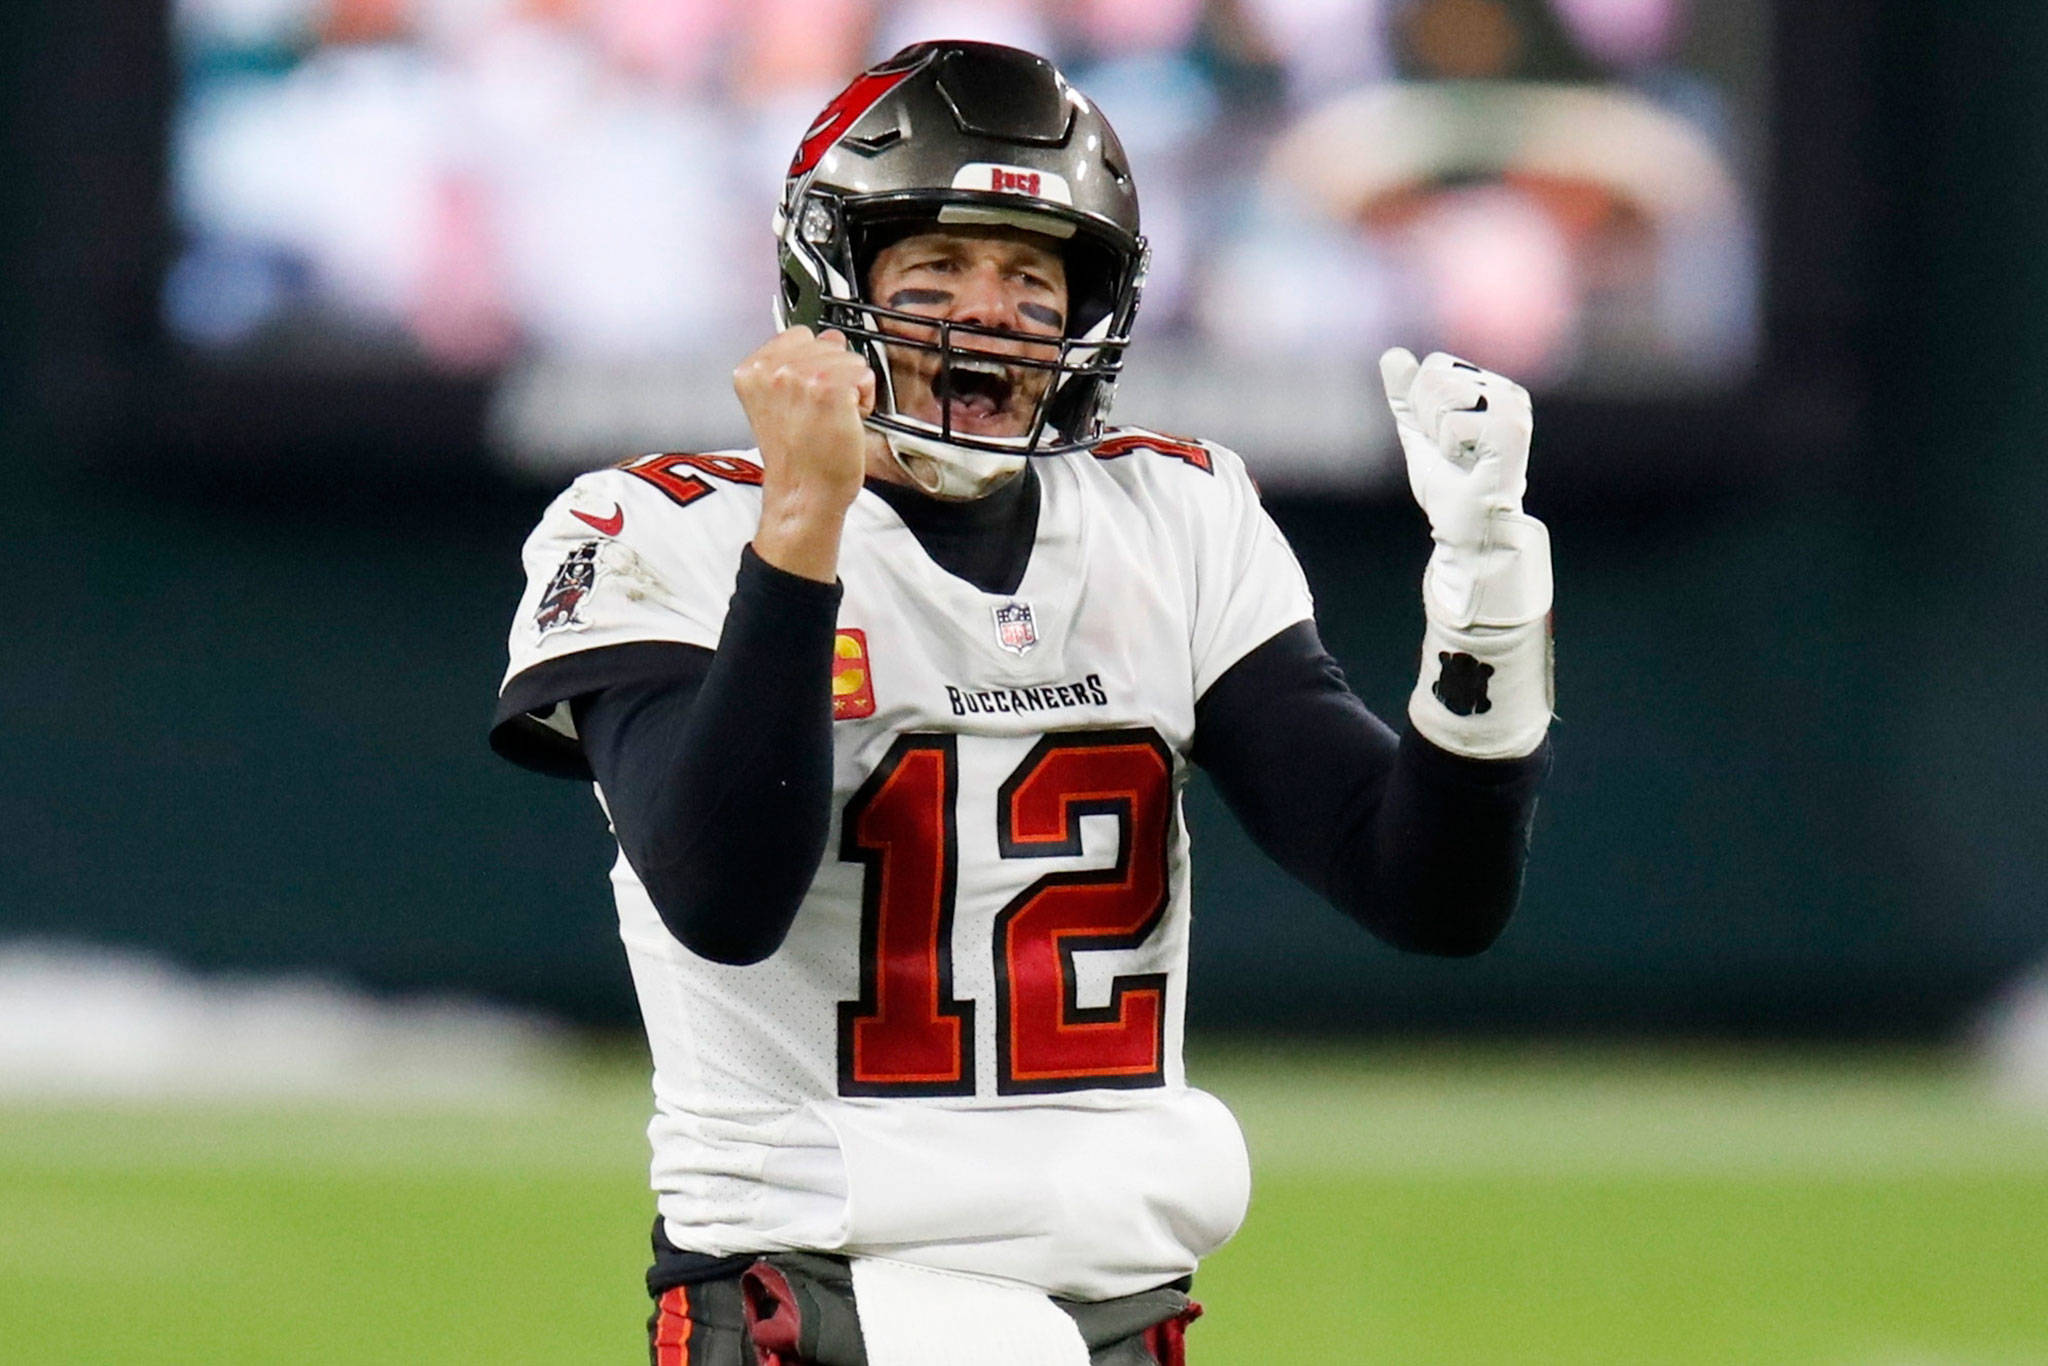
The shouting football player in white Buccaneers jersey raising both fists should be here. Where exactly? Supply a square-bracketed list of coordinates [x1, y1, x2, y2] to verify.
[492, 43, 1550, 1366]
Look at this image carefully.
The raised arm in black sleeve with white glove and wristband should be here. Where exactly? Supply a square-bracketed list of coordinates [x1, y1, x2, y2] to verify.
[1192, 350, 1550, 954]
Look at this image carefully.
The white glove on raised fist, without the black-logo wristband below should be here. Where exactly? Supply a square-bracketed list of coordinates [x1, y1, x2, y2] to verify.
[1380, 346, 1550, 629]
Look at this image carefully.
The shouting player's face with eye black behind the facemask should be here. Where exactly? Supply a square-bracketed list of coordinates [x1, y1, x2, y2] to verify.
[868, 225, 1067, 436]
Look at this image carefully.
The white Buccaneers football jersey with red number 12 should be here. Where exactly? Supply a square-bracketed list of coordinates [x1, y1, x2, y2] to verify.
[506, 428, 1313, 1298]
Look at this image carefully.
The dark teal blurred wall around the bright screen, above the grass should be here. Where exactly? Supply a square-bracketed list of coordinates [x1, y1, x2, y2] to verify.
[0, 0, 2023, 1036]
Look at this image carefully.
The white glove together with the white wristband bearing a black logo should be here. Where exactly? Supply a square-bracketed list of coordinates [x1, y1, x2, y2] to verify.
[1380, 346, 1552, 760]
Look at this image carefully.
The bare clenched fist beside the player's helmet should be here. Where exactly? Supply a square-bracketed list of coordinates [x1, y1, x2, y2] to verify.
[733, 328, 874, 584]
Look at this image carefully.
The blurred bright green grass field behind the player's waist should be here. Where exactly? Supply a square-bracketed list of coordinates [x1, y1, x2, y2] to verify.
[0, 1044, 2048, 1366]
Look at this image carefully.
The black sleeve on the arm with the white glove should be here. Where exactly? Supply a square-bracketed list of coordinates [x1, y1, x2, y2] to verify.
[1192, 623, 1550, 956]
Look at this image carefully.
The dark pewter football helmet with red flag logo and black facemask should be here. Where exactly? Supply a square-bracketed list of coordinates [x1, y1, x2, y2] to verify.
[774, 41, 1147, 498]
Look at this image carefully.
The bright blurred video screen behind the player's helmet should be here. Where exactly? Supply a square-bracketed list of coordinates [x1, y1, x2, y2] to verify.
[162, 0, 1769, 485]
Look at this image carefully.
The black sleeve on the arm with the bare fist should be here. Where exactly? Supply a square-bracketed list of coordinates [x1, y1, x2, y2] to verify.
[571, 547, 840, 965]
